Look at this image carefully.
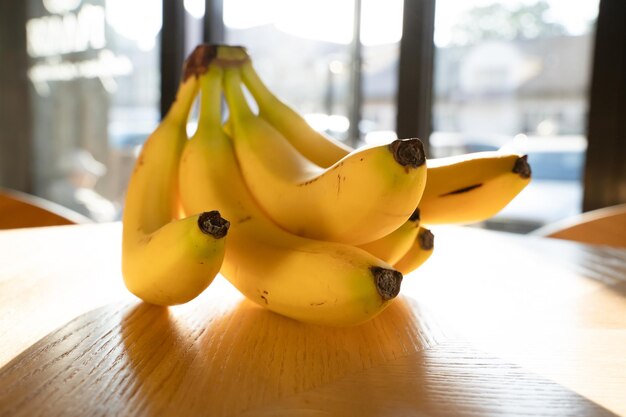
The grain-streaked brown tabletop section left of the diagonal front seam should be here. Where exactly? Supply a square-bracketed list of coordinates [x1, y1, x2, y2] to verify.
[0, 292, 443, 416]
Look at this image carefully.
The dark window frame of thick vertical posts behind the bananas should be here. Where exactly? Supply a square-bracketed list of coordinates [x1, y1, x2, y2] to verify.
[0, 0, 626, 211]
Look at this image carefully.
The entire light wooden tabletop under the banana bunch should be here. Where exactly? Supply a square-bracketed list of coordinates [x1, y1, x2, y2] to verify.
[0, 219, 626, 416]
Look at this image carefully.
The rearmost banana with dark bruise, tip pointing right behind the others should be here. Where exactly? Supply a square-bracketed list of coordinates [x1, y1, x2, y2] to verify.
[249, 92, 531, 224]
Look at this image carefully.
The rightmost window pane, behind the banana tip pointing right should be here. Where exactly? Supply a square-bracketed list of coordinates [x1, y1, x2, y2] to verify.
[430, 0, 598, 232]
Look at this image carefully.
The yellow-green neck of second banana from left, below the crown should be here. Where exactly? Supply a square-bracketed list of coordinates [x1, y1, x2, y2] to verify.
[198, 65, 223, 132]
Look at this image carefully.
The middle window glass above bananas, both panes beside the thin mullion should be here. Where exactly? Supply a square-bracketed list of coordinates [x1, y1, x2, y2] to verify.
[224, 0, 402, 145]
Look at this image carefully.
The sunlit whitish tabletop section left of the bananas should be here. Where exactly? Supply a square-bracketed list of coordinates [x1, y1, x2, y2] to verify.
[0, 223, 131, 366]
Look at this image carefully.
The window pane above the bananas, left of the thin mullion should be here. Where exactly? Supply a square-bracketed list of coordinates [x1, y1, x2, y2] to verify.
[224, 0, 353, 139]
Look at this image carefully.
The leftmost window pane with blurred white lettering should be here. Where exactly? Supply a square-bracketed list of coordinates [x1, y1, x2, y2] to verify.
[26, 0, 161, 221]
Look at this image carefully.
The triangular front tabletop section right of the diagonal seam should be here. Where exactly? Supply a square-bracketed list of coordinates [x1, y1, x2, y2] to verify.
[243, 341, 615, 416]
